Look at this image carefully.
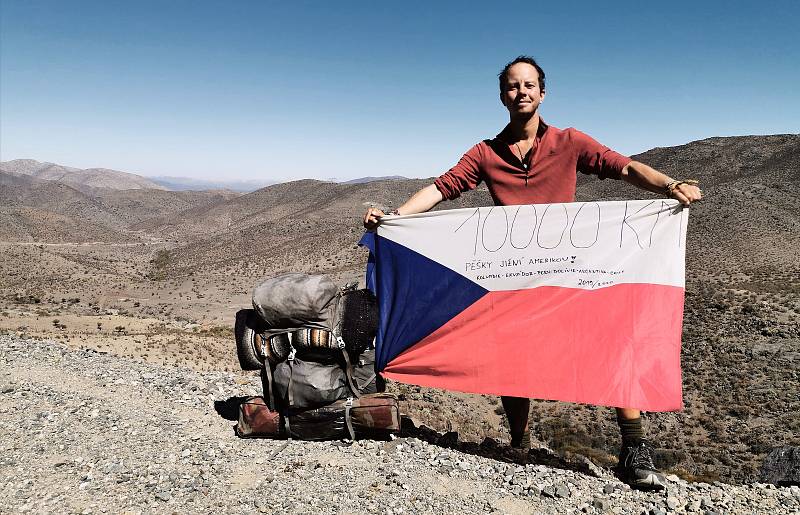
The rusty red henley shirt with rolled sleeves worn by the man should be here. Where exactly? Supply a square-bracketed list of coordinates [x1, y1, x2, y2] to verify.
[434, 120, 631, 205]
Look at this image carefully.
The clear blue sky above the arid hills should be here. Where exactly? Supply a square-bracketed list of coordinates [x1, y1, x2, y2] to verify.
[0, 0, 800, 181]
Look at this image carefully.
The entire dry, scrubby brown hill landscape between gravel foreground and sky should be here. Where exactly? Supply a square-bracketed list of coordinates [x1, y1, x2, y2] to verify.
[0, 135, 800, 482]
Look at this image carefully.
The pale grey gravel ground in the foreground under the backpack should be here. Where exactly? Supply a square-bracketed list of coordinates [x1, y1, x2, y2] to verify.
[0, 336, 800, 515]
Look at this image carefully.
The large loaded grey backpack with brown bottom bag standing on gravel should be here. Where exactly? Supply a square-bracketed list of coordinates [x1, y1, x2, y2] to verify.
[236, 273, 400, 440]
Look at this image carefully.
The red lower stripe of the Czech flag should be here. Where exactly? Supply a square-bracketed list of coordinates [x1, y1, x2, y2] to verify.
[383, 284, 684, 411]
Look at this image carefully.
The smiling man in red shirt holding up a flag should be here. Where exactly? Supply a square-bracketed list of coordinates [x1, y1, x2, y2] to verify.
[364, 56, 702, 490]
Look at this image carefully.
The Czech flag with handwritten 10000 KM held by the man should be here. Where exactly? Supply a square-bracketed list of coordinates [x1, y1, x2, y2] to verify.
[361, 200, 688, 411]
